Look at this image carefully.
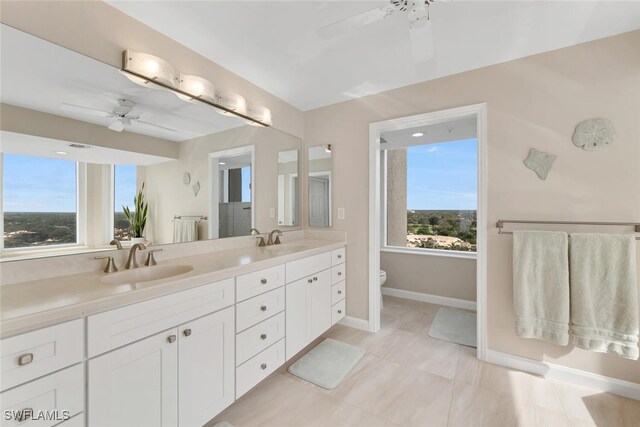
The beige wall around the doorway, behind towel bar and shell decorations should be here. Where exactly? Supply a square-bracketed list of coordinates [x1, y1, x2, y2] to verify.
[305, 31, 640, 382]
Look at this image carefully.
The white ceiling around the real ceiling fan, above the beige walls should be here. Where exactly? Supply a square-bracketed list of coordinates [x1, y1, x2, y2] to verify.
[107, 0, 640, 110]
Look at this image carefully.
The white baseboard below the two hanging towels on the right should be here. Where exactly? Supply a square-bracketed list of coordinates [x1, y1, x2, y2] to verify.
[487, 349, 640, 400]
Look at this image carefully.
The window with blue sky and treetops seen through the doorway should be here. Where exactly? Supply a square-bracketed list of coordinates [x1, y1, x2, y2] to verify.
[383, 138, 477, 252]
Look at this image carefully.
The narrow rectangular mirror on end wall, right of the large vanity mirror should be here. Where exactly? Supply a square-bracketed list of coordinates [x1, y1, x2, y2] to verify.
[307, 144, 332, 227]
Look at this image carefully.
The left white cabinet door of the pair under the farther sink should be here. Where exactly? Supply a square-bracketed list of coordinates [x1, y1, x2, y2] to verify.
[286, 277, 313, 360]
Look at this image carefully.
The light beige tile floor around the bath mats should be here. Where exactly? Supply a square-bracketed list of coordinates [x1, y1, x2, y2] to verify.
[209, 296, 640, 427]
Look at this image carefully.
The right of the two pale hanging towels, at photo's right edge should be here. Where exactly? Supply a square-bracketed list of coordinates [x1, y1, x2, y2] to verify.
[569, 233, 638, 360]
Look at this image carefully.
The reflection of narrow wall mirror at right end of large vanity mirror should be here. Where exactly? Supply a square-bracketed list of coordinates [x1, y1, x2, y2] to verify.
[278, 150, 298, 225]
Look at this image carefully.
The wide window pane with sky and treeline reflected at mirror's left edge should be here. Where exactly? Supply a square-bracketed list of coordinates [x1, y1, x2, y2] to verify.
[2, 153, 80, 249]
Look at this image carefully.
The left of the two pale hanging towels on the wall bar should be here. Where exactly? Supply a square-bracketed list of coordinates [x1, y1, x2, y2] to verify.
[513, 231, 569, 345]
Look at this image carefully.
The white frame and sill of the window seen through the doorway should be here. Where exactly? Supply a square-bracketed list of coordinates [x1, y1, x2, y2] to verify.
[380, 141, 478, 259]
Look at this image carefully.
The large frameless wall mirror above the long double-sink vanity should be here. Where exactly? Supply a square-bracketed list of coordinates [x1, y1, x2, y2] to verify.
[0, 25, 301, 260]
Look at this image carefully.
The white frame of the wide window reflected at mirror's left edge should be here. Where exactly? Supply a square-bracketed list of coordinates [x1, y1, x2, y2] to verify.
[0, 153, 87, 255]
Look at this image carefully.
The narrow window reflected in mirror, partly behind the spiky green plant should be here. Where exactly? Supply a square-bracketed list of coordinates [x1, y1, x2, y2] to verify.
[113, 165, 138, 241]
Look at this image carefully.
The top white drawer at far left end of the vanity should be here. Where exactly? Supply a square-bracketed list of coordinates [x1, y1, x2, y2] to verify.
[0, 319, 84, 390]
